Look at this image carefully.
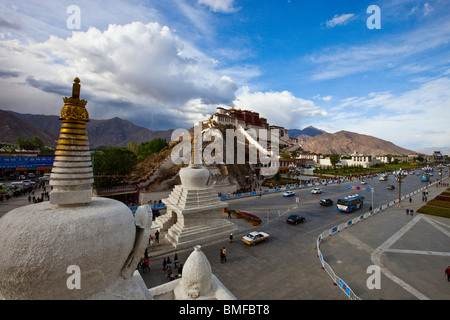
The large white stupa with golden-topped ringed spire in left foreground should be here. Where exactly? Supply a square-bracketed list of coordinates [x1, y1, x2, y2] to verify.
[0, 78, 152, 300]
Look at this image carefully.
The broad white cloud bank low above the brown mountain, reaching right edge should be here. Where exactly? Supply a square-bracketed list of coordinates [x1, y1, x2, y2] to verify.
[313, 77, 450, 150]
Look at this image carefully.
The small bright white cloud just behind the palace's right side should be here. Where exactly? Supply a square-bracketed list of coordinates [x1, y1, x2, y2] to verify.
[234, 87, 328, 129]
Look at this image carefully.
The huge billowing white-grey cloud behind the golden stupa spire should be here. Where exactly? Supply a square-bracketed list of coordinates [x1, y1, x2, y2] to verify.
[0, 22, 243, 129]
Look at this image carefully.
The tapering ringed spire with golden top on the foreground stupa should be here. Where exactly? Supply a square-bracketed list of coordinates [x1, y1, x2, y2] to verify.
[50, 78, 94, 205]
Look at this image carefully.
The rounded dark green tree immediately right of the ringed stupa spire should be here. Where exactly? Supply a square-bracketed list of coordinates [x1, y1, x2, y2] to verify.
[92, 147, 137, 189]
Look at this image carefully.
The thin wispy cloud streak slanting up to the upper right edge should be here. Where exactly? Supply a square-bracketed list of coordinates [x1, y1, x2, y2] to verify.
[305, 15, 450, 80]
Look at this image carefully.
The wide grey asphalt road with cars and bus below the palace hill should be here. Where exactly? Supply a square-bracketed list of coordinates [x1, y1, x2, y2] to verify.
[143, 170, 450, 300]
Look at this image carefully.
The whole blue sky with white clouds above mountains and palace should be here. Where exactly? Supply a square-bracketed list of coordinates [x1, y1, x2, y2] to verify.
[0, 0, 450, 150]
